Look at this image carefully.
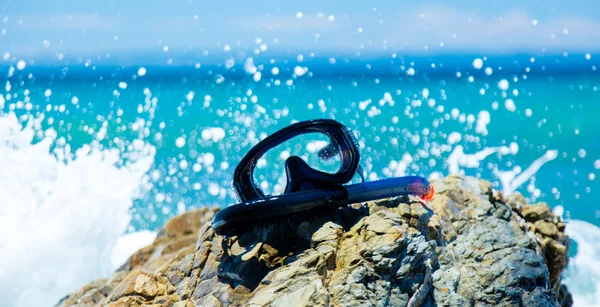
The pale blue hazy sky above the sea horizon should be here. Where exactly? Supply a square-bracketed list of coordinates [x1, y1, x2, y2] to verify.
[0, 0, 600, 60]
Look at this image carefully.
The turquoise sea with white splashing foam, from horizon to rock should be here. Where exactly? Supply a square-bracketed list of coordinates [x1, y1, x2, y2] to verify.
[0, 53, 600, 306]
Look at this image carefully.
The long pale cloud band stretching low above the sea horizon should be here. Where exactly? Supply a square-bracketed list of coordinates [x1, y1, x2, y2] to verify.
[0, 5, 600, 56]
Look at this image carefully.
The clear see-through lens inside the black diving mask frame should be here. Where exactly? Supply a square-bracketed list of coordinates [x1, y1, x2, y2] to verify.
[253, 133, 342, 195]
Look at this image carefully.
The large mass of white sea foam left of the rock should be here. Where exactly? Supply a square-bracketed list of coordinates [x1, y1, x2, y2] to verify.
[0, 113, 155, 307]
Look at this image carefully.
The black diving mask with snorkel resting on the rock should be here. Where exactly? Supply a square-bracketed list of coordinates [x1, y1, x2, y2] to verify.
[212, 119, 434, 236]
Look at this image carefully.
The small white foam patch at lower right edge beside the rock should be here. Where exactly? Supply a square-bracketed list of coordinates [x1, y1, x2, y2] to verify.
[563, 220, 600, 307]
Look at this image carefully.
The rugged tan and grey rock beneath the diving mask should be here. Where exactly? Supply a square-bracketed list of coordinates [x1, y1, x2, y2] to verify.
[59, 176, 572, 306]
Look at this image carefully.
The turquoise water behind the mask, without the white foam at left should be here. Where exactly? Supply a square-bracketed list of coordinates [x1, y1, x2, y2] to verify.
[0, 56, 600, 230]
